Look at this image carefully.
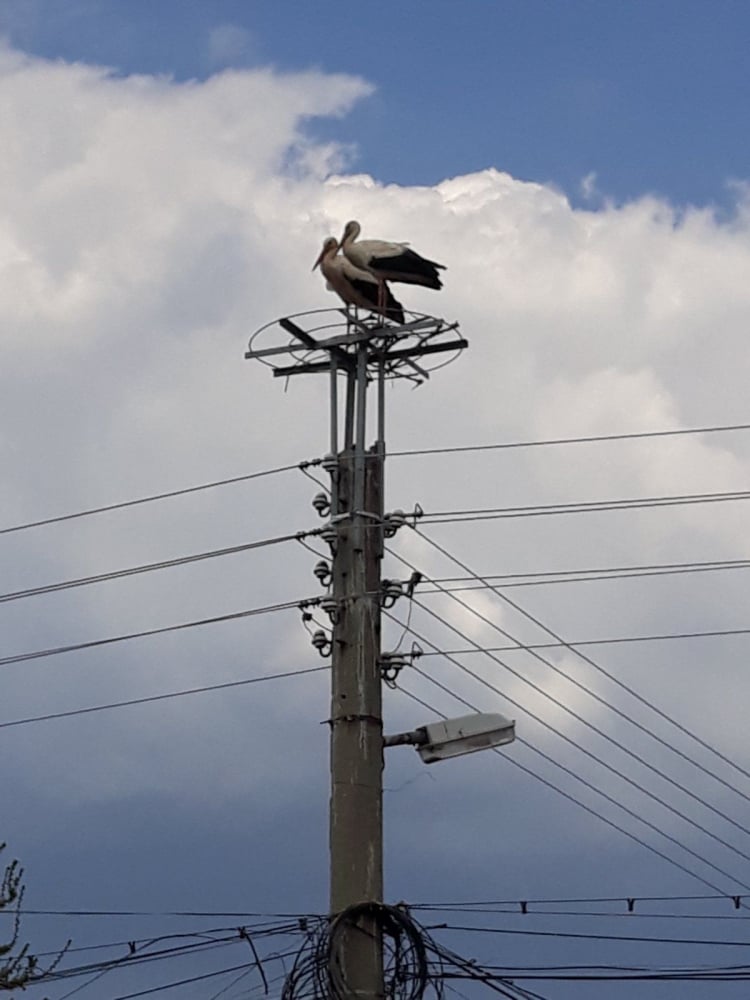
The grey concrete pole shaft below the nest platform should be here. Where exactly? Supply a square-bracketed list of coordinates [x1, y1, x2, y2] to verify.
[330, 398, 383, 1000]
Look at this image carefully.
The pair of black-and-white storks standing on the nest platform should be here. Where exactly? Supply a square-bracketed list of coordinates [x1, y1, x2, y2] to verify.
[313, 221, 445, 323]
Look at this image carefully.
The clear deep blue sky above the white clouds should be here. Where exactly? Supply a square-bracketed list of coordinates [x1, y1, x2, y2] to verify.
[5, 0, 750, 205]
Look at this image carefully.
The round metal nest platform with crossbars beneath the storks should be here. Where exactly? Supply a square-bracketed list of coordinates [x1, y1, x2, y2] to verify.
[245, 309, 469, 383]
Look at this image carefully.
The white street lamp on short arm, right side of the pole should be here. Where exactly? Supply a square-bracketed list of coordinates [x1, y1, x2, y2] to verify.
[383, 712, 516, 764]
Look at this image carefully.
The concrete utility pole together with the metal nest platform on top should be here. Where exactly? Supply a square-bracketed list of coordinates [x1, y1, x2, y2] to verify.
[245, 309, 468, 1000]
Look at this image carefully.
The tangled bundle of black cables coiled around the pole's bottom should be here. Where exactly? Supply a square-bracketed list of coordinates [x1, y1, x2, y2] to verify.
[281, 902, 442, 1000]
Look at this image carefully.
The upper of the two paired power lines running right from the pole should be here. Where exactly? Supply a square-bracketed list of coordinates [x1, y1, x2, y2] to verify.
[422, 490, 750, 524]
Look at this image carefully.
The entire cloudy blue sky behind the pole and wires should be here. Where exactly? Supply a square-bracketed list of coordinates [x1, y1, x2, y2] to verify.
[0, 0, 750, 1000]
